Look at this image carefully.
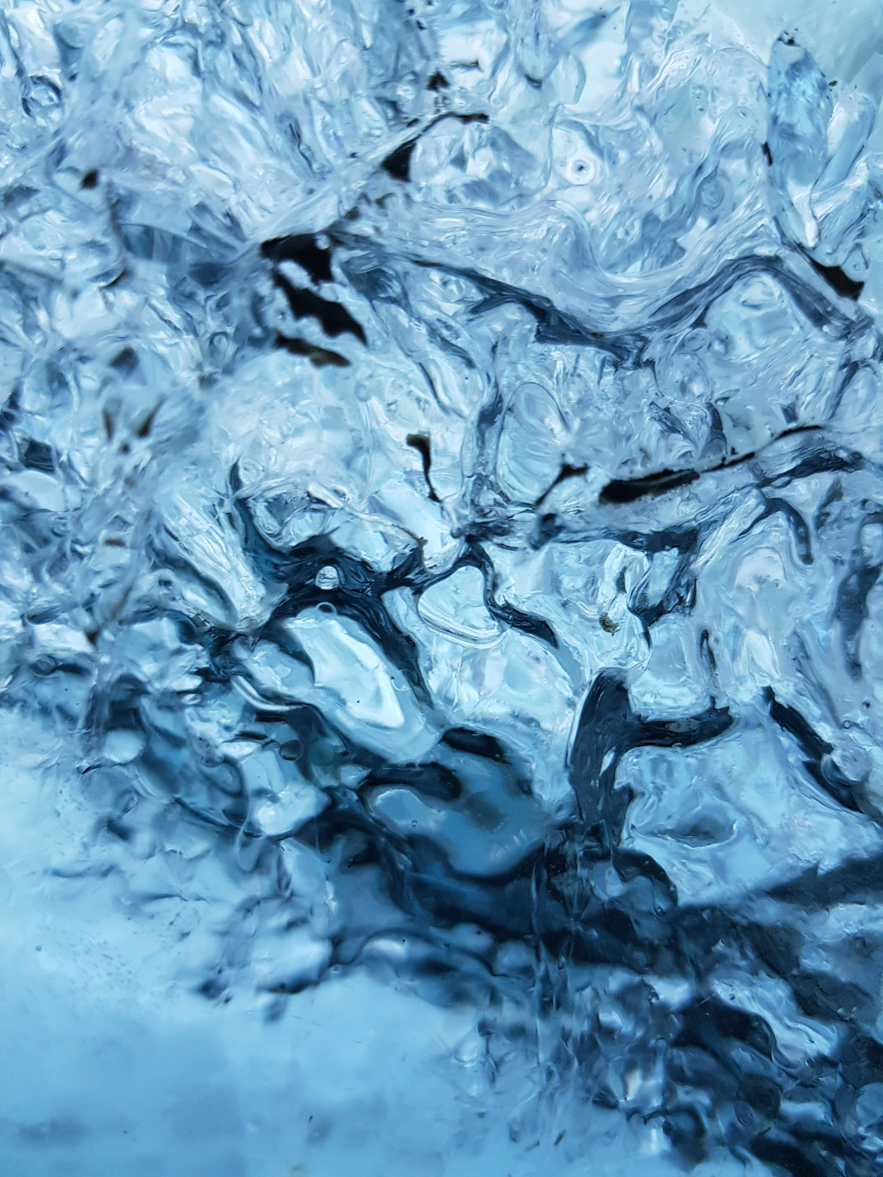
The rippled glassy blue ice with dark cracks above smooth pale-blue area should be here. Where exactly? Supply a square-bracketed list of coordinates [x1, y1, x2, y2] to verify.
[0, 0, 883, 1177]
